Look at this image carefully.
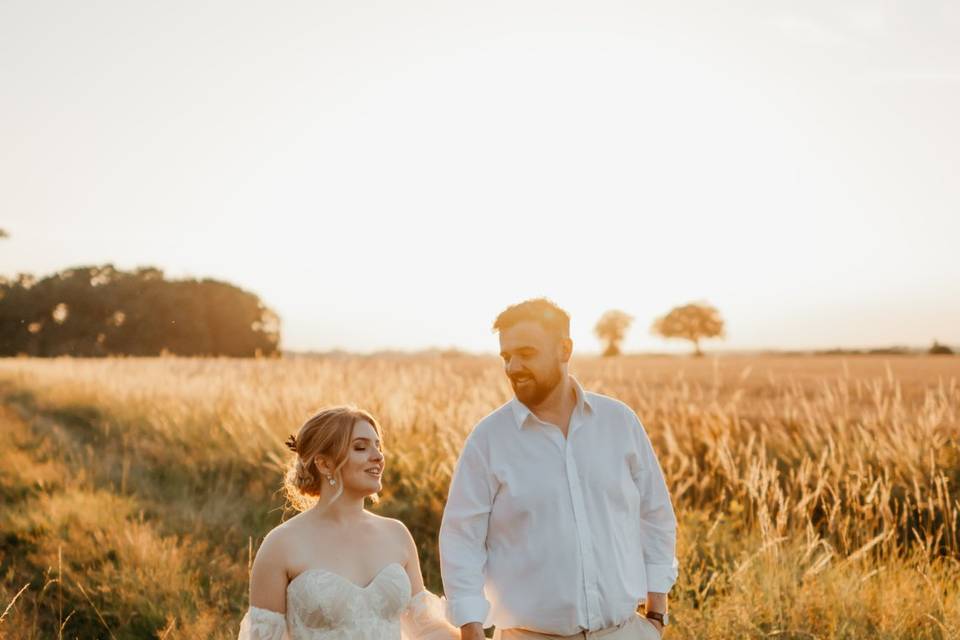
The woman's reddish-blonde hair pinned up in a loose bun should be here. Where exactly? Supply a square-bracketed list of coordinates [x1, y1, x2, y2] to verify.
[283, 406, 382, 511]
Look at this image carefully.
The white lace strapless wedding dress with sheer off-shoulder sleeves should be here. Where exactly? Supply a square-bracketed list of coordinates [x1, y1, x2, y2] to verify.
[237, 563, 460, 640]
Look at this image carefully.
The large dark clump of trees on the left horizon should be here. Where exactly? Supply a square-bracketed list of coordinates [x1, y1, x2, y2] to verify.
[0, 265, 280, 357]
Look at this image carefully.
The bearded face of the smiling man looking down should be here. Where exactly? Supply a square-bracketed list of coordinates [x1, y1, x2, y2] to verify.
[500, 321, 570, 407]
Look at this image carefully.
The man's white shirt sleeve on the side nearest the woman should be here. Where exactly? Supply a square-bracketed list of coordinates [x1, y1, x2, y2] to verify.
[440, 439, 495, 627]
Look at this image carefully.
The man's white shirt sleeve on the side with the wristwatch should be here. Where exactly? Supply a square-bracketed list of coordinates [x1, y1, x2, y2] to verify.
[626, 408, 679, 593]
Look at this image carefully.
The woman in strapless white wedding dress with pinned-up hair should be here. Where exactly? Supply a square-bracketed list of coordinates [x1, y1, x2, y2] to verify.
[238, 407, 460, 640]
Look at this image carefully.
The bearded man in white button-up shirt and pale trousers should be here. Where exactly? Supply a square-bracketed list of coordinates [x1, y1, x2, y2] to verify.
[440, 298, 677, 640]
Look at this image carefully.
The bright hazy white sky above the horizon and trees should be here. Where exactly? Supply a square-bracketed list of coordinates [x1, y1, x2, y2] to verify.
[0, 0, 960, 351]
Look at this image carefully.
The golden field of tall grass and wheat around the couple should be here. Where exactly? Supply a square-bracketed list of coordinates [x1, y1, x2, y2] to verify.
[0, 355, 960, 640]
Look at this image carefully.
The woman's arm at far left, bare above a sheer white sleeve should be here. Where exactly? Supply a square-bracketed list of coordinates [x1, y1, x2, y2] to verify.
[237, 531, 287, 640]
